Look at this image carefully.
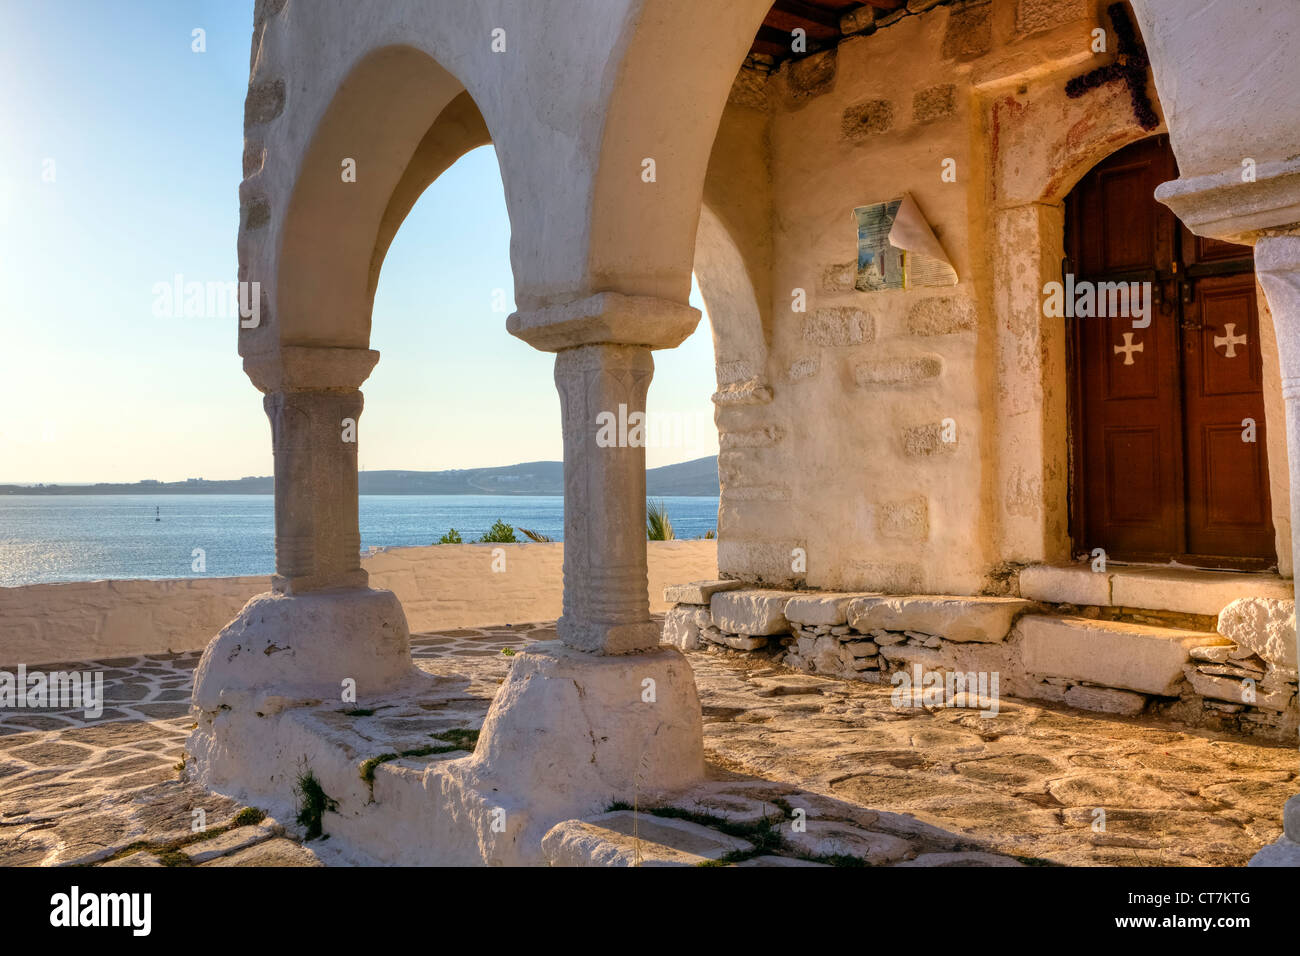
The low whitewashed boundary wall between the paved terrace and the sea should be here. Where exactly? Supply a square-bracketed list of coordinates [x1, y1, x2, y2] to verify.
[0, 541, 718, 667]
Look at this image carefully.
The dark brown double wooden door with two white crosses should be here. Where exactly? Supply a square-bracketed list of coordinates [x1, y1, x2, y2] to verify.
[1063, 137, 1275, 567]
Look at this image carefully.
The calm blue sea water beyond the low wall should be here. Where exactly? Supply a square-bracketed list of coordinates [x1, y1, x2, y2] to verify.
[0, 494, 718, 588]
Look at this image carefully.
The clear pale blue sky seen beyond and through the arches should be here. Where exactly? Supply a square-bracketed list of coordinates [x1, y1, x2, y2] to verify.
[0, 0, 718, 483]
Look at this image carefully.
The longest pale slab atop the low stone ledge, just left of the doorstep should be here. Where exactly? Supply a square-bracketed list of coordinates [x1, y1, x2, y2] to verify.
[849, 594, 1032, 644]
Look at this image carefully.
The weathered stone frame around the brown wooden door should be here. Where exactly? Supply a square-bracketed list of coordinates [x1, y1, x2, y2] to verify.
[975, 74, 1291, 575]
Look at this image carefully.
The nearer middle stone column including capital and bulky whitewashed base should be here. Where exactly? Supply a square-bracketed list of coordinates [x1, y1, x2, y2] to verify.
[467, 293, 705, 816]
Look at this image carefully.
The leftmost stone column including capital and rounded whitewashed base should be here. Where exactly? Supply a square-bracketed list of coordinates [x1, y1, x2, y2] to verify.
[187, 346, 417, 788]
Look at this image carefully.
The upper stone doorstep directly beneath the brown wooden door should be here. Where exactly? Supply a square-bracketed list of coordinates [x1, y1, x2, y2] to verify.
[1019, 564, 1295, 617]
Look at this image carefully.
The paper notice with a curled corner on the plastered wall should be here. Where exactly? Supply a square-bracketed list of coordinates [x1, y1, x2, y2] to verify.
[853, 193, 957, 293]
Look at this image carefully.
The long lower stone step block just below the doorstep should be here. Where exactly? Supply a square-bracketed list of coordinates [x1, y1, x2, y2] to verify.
[1017, 614, 1229, 697]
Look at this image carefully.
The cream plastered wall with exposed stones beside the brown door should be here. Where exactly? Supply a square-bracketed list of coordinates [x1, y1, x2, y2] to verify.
[697, 0, 1290, 594]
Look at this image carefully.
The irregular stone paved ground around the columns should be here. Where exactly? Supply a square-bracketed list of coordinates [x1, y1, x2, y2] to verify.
[0, 624, 1297, 866]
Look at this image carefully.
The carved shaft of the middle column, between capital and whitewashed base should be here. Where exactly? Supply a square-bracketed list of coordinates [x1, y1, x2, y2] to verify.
[555, 345, 659, 654]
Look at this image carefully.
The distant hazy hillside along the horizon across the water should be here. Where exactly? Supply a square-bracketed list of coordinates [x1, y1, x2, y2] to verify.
[0, 455, 718, 498]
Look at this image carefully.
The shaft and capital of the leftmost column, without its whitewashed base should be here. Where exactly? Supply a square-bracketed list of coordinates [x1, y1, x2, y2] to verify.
[244, 347, 378, 594]
